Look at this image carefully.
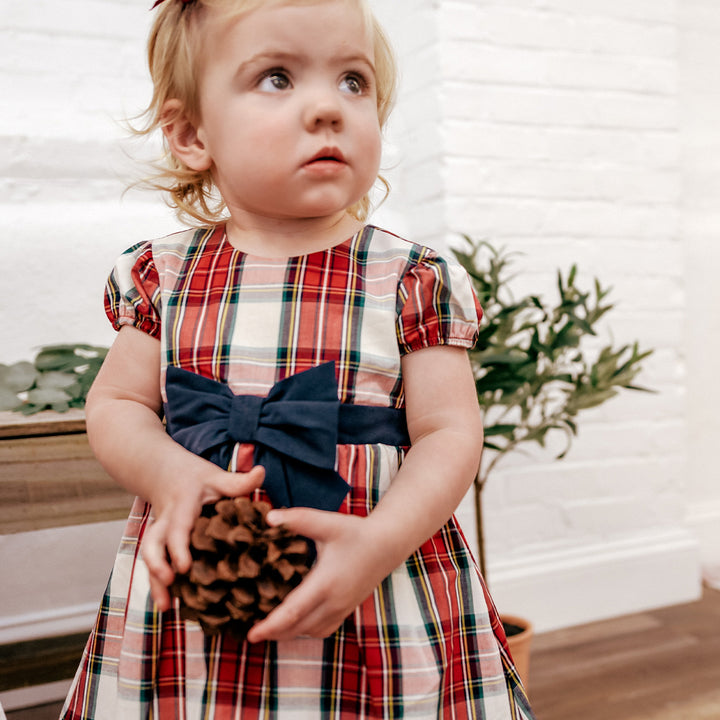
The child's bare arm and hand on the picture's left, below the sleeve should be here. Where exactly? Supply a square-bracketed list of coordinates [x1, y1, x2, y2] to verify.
[85, 327, 264, 610]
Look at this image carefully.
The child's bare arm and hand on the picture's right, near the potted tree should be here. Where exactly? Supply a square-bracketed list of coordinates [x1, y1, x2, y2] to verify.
[248, 346, 483, 642]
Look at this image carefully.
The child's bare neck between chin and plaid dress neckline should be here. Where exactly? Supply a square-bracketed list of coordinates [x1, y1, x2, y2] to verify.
[225, 212, 363, 258]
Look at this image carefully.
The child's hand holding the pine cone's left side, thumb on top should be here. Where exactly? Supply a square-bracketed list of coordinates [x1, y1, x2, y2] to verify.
[141, 463, 265, 611]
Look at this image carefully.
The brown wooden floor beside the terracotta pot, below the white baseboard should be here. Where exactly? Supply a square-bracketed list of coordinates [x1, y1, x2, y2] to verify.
[7, 589, 720, 720]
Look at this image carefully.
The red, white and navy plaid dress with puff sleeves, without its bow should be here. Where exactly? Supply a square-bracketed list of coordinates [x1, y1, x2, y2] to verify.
[62, 226, 533, 720]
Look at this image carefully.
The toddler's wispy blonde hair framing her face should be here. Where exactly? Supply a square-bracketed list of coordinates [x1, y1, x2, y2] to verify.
[134, 0, 397, 226]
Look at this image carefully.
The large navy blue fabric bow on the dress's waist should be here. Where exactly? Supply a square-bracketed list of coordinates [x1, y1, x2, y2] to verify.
[165, 362, 350, 510]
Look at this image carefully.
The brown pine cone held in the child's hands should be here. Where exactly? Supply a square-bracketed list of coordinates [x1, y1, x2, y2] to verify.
[170, 497, 315, 640]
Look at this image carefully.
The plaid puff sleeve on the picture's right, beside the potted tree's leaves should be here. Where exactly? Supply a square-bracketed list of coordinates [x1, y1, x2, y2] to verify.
[397, 248, 482, 355]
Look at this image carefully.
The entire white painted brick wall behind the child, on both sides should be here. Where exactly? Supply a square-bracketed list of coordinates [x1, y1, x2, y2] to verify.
[0, 0, 720, 640]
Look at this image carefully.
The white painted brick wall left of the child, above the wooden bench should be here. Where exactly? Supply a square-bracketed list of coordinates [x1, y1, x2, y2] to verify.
[0, 0, 181, 362]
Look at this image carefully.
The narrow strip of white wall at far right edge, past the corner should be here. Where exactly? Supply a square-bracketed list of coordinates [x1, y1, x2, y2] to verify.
[678, 0, 720, 584]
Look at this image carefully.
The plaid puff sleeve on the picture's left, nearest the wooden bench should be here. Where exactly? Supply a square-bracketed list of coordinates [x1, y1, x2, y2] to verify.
[105, 242, 161, 338]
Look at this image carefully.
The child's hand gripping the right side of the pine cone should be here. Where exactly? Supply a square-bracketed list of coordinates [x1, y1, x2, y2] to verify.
[247, 508, 397, 642]
